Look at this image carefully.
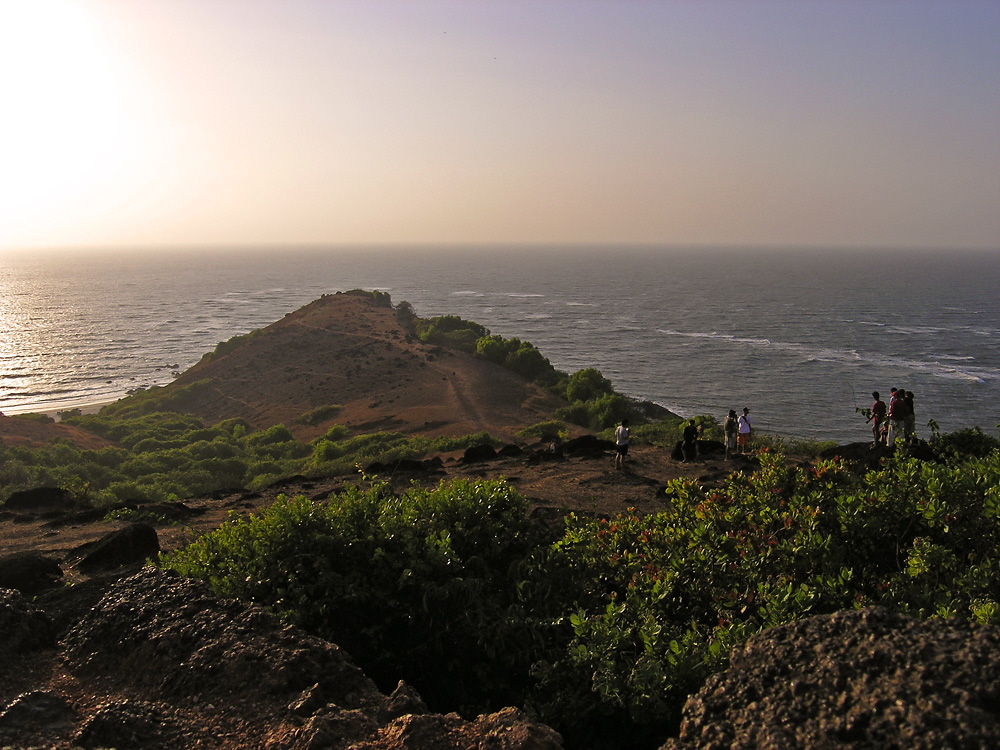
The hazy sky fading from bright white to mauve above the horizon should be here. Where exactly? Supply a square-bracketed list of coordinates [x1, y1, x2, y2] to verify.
[0, 0, 1000, 252]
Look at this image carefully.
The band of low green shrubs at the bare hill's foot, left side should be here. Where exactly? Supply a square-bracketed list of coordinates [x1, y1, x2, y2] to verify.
[0, 412, 500, 506]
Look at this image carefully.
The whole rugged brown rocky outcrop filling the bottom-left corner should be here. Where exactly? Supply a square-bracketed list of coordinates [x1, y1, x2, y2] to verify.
[0, 567, 562, 750]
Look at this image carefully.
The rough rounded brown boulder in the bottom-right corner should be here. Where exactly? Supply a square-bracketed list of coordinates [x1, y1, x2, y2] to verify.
[663, 608, 1000, 750]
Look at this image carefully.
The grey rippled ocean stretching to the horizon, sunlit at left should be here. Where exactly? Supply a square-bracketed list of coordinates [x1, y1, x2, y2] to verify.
[0, 246, 1000, 442]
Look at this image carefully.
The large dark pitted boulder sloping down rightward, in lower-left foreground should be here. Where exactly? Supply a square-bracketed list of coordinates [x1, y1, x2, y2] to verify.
[63, 567, 384, 708]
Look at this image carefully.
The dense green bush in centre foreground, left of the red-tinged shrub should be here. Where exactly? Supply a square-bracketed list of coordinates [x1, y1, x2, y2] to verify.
[164, 481, 556, 713]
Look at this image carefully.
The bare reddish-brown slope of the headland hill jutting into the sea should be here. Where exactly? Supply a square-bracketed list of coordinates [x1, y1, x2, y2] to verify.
[165, 293, 564, 439]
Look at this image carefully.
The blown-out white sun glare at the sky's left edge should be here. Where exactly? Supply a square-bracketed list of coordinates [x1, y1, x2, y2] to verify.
[0, 0, 146, 245]
